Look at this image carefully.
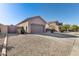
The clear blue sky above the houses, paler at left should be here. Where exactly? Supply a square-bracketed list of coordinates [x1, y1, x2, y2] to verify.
[0, 3, 79, 25]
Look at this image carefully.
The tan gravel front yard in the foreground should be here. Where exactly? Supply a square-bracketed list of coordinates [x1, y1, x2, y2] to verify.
[7, 34, 77, 56]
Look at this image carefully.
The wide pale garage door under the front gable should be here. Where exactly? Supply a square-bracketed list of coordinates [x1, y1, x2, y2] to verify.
[31, 24, 44, 33]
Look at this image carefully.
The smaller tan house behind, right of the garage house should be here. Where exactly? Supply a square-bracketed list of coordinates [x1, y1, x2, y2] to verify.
[46, 21, 62, 32]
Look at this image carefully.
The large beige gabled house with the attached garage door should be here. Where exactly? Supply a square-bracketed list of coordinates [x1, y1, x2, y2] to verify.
[16, 16, 46, 33]
